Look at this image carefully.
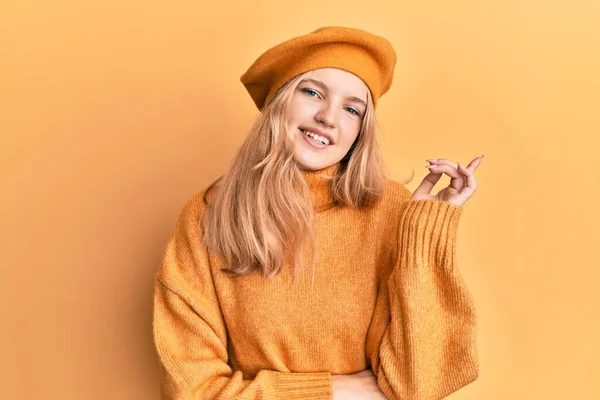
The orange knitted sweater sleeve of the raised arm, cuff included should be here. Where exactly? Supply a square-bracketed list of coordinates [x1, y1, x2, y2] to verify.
[367, 199, 479, 400]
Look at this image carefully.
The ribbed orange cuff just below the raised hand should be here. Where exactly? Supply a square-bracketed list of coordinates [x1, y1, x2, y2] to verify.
[398, 200, 463, 268]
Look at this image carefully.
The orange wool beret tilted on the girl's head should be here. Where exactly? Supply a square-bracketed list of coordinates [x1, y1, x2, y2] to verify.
[240, 26, 396, 110]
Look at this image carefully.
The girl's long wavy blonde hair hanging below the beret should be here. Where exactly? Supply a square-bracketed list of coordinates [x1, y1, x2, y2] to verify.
[203, 71, 388, 281]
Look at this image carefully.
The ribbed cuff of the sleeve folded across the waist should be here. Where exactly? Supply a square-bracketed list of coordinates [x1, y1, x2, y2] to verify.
[275, 372, 332, 400]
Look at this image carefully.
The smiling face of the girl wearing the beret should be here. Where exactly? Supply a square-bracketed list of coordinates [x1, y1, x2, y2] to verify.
[286, 68, 368, 170]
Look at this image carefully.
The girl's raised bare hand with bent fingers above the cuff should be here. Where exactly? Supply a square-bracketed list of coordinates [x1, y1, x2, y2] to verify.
[411, 156, 483, 206]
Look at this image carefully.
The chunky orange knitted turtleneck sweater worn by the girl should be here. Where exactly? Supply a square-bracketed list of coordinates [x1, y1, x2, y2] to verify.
[153, 164, 479, 400]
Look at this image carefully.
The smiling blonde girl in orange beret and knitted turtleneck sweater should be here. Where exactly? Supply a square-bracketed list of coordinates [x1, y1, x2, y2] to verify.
[153, 27, 481, 400]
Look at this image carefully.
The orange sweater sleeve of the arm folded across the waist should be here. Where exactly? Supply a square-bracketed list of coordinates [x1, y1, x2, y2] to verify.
[152, 201, 332, 400]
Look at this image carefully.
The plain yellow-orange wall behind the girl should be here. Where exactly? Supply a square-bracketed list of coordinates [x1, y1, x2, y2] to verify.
[0, 0, 600, 400]
